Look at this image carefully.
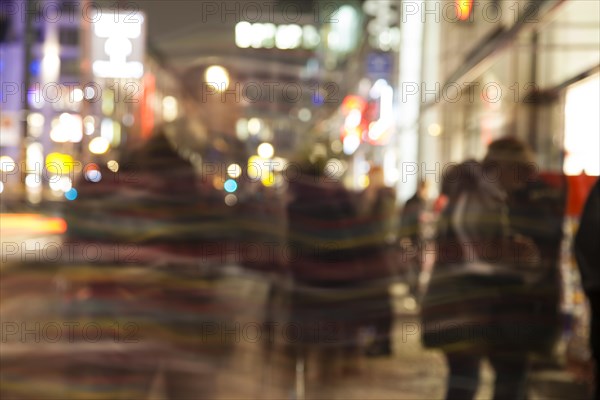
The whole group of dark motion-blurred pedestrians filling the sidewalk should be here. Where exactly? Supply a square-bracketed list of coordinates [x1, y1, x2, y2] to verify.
[3, 66, 599, 399]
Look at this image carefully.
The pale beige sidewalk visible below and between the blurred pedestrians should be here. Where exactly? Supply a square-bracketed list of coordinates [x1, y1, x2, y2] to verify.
[198, 278, 588, 400]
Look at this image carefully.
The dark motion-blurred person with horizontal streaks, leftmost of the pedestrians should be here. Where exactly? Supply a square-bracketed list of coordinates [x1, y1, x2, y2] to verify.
[59, 67, 244, 399]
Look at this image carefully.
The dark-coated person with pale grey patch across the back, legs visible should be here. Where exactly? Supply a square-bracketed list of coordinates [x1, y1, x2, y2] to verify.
[422, 138, 557, 399]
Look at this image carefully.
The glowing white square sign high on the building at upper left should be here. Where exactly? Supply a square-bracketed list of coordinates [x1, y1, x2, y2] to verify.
[92, 11, 145, 79]
